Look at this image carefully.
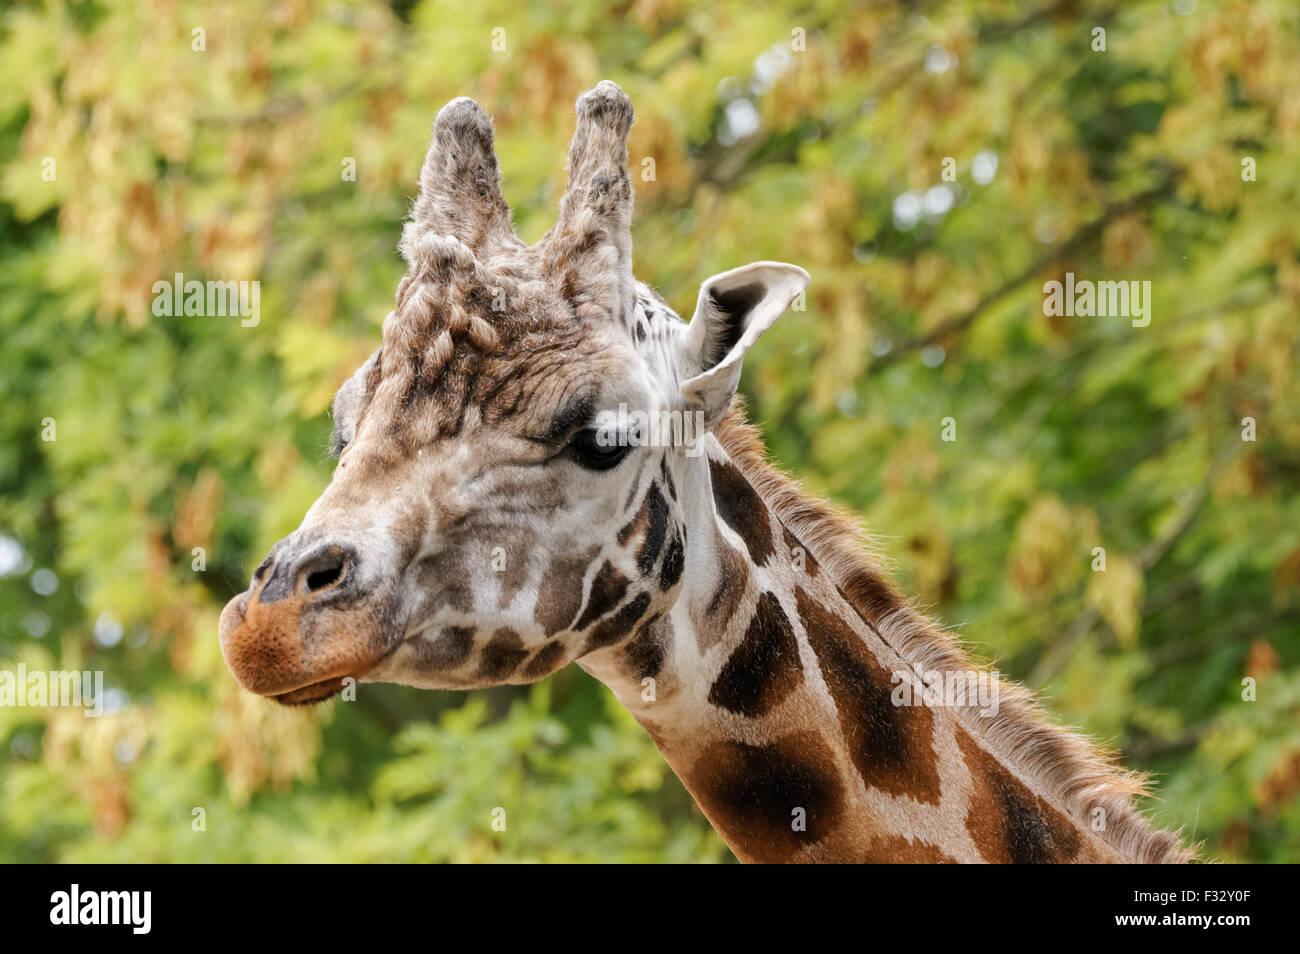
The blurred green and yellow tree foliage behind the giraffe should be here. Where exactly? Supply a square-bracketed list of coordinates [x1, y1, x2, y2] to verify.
[0, 0, 1300, 862]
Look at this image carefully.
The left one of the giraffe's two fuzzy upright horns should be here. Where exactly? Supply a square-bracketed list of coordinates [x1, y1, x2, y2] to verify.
[402, 96, 521, 263]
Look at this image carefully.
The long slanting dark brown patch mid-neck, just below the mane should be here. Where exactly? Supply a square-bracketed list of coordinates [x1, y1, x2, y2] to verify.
[794, 587, 940, 805]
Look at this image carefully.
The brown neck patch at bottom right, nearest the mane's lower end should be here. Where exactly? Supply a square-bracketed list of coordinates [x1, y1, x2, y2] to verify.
[957, 727, 1080, 864]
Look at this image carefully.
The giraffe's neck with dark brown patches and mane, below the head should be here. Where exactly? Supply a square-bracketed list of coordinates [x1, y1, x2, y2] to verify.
[582, 415, 1178, 862]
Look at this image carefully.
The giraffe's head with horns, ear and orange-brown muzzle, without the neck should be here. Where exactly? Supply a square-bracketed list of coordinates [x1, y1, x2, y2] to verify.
[220, 82, 807, 704]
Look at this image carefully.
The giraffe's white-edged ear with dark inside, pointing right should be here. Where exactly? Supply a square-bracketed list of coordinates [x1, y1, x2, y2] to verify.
[680, 261, 809, 428]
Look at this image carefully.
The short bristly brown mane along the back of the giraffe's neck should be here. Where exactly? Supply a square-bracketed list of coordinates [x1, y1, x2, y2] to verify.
[714, 396, 1196, 864]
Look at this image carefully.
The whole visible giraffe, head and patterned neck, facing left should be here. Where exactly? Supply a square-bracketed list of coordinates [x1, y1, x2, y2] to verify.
[220, 81, 1193, 862]
